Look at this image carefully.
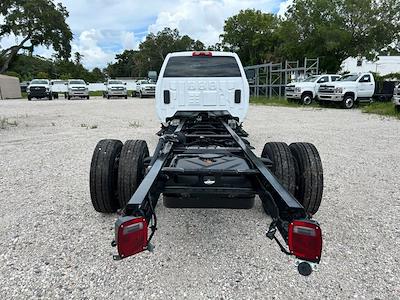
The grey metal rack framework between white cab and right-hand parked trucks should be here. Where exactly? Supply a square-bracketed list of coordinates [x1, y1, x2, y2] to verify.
[244, 58, 319, 97]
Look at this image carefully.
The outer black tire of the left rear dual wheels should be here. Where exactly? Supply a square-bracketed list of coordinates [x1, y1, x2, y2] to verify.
[90, 140, 122, 213]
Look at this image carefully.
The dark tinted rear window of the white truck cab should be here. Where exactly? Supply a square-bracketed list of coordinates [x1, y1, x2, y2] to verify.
[163, 56, 242, 77]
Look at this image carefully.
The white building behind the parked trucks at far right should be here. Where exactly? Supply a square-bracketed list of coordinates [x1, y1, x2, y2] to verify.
[341, 56, 400, 76]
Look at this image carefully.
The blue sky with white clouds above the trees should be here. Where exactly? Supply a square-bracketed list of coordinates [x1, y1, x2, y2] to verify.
[0, 0, 293, 69]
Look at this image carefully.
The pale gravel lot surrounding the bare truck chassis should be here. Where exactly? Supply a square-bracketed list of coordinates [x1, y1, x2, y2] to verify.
[0, 99, 400, 299]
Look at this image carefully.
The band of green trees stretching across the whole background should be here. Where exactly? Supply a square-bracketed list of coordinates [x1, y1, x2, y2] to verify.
[0, 0, 400, 81]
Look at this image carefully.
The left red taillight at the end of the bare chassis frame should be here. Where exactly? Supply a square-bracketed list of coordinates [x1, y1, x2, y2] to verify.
[115, 216, 148, 258]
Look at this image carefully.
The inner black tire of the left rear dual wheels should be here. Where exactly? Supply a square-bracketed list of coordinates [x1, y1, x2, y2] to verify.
[118, 140, 149, 208]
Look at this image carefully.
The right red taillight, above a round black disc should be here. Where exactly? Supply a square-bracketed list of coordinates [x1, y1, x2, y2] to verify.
[288, 220, 322, 262]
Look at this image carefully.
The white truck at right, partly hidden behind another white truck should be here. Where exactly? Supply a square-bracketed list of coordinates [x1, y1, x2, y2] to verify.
[285, 74, 340, 105]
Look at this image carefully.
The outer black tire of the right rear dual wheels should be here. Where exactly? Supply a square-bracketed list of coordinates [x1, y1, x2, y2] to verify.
[289, 143, 324, 215]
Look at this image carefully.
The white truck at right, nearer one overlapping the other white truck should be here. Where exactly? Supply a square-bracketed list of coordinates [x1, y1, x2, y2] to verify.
[317, 73, 375, 109]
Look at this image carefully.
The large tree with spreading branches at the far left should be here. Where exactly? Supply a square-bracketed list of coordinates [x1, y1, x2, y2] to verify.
[0, 0, 72, 73]
